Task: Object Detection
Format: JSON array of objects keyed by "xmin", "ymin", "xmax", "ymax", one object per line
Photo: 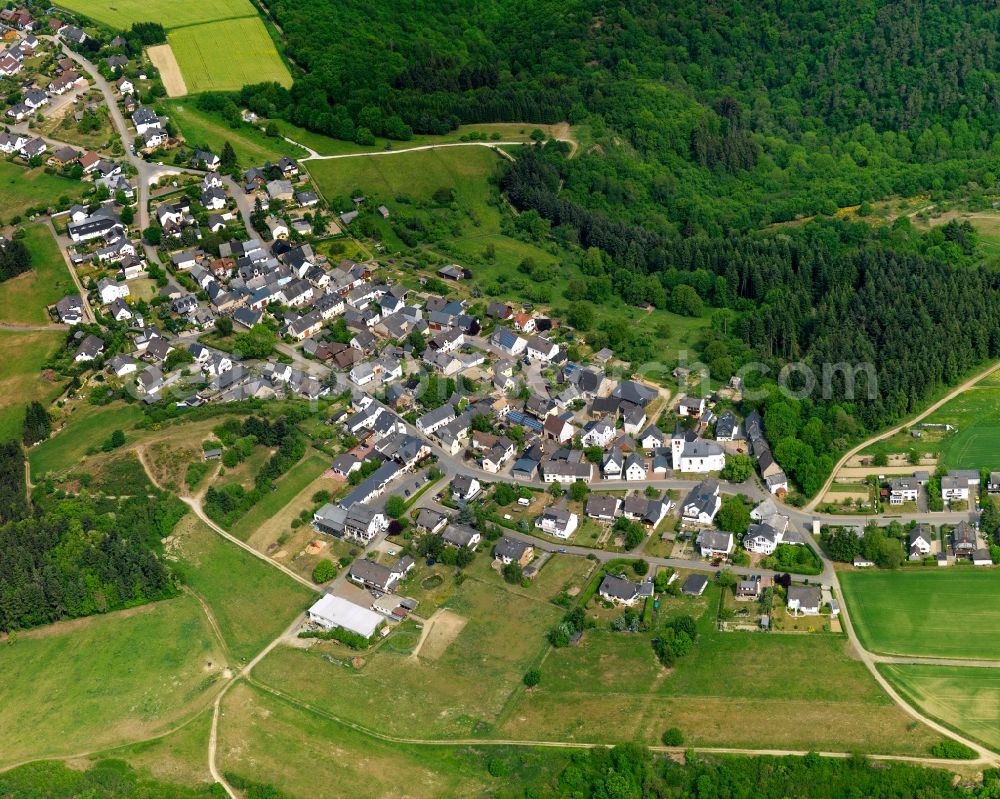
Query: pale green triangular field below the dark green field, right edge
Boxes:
[{"xmin": 879, "ymin": 664, "xmax": 1000, "ymax": 751}]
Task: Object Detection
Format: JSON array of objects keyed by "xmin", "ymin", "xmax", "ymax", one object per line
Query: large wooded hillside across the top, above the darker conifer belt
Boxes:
[{"xmin": 252, "ymin": 0, "xmax": 1000, "ymax": 230}]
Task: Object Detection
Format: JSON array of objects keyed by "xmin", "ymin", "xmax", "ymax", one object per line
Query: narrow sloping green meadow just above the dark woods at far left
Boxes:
[{"xmin": 28, "ymin": 403, "xmax": 142, "ymax": 480}]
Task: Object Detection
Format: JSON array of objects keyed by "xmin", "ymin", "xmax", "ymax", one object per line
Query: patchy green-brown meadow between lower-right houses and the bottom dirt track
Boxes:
[{"xmin": 500, "ymin": 586, "xmax": 938, "ymax": 753}]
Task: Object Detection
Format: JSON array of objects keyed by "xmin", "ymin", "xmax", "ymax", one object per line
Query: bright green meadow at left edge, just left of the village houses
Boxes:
[{"xmin": 0, "ymin": 225, "xmax": 77, "ymax": 325}]
